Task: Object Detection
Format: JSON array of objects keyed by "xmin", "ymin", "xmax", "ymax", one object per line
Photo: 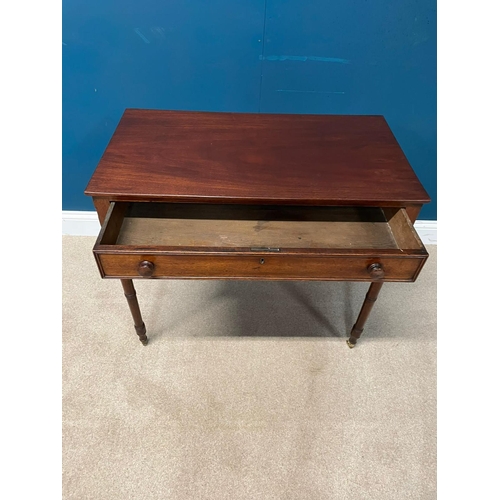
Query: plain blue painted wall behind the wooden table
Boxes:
[{"xmin": 62, "ymin": 0, "xmax": 437, "ymax": 219}]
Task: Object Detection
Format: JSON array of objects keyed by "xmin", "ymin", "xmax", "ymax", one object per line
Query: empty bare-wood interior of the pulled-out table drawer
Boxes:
[{"xmin": 98, "ymin": 202, "xmax": 425, "ymax": 253}]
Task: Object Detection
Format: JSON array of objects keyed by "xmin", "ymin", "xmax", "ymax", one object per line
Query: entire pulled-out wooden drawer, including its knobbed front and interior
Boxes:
[{"xmin": 94, "ymin": 202, "xmax": 428, "ymax": 281}]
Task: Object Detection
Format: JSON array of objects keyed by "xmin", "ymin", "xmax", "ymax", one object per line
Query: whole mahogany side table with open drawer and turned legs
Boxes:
[{"xmin": 85, "ymin": 109, "xmax": 430, "ymax": 347}]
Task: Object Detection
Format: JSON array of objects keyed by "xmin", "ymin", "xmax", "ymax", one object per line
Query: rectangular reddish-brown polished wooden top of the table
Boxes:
[{"xmin": 85, "ymin": 109, "xmax": 430, "ymax": 206}]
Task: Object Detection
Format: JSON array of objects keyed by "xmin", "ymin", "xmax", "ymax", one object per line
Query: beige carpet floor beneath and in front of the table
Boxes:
[{"xmin": 63, "ymin": 236, "xmax": 437, "ymax": 500}]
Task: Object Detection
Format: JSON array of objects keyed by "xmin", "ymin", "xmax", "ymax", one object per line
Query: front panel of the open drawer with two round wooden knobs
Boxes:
[{"xmin": 96, "ymin": 253, "xmax": 426, "ymax": 281}]
